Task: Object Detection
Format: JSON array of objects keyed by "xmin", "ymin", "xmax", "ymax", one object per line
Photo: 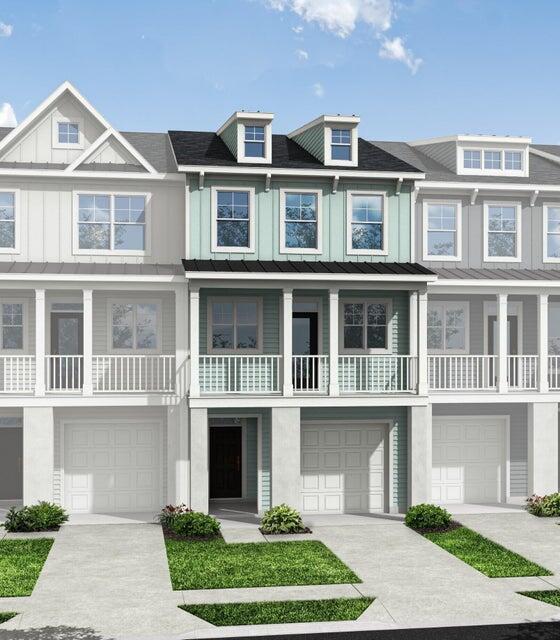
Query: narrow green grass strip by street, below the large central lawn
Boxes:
[{"xmin": 180, "ymin": 598, "xmax": 373, "ymax": 627}]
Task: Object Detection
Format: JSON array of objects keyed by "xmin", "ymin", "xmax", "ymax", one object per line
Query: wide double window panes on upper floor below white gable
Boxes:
[{"xmin": 78, "ymin": 193, "xmax": 147, "ymax": 253}]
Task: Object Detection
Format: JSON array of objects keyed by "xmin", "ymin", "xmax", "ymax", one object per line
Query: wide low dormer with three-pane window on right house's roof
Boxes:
[{"xmin": 410, "ymin": 135, "xmax": 531, "ymax": 178}]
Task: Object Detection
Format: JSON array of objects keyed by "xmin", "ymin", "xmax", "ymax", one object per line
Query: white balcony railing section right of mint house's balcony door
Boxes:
[{"xmin": 338, "ymin": 355, "xmax": 417, "ymax": 393}]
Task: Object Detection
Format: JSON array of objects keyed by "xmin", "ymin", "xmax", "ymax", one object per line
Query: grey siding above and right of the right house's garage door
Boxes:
[{"xmin": 432, "ymin": 403, "xmax": 527, "ymax": 497}]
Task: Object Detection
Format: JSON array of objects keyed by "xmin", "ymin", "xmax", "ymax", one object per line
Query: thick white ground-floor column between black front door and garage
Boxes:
[{"xmin": 271, "ymin": 407, "xmax": 301, "ymax": 511}]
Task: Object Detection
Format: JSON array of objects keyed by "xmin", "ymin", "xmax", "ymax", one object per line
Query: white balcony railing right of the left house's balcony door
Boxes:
[{"xmin": 93, "ymin": 355, "xmax": 175, "ymax": 393}]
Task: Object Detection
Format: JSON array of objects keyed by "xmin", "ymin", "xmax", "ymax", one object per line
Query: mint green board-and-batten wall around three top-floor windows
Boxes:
[{"xmin": 187, "ymin": 177, "xmax": 410, "ymax": 262}]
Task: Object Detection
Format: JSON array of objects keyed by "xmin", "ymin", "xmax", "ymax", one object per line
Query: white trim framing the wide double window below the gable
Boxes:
[{"xmin": 72, "ymin": 190, "xmax": 152, "ymax": 256}]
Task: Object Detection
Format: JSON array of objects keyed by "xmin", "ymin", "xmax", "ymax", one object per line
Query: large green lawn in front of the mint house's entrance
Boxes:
[{"xmin": 165, "ymin": 538, "xmax": 361, "ymax": 590}]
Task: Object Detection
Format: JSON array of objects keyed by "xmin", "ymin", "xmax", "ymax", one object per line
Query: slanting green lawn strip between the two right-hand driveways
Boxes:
[{"xmin": 424, "ymin": 527, "xmax": 552, "ymax": 578}]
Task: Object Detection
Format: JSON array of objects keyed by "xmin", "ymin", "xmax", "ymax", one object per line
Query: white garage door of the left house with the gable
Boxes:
[{"xmin": 63, "ymin": 421, "xmax": 162, "ymax": 513}]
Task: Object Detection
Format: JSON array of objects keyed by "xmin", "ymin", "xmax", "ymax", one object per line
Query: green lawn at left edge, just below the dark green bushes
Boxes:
[{"xmin": 0, "ymin": 538, "xmax": 54, "ymax": 597}]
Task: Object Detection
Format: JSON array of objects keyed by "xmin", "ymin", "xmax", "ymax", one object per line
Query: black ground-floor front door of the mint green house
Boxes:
[{"xmin": 210, "ymin": 426, "xmax": 243, "ymax": 498}]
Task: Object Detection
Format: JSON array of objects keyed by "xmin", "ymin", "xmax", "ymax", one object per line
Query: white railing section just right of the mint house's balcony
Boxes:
[{"xmin": 428, "ymin": 355, "xmax": 498, "ymax": 391}]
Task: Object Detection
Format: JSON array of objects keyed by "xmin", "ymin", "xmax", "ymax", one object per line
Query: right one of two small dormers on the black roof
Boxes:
[{"xmin": 288, "ymin": 115, "xmax": 360, "ymax": 167}]
